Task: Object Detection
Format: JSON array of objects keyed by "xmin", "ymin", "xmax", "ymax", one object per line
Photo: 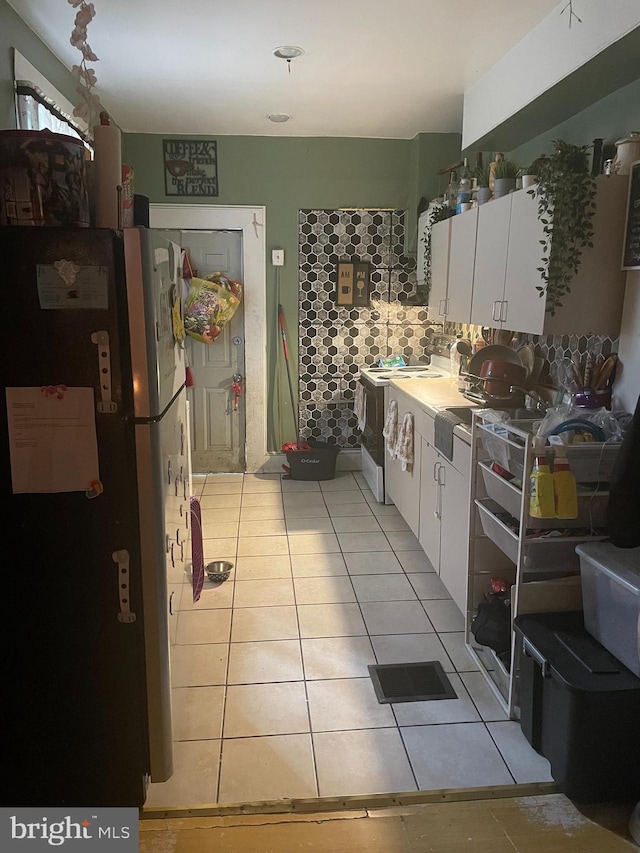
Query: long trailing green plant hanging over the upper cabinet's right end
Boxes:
[{"xmin": 528, "ymin": 140, "xmax": 596, "ymax": 316}]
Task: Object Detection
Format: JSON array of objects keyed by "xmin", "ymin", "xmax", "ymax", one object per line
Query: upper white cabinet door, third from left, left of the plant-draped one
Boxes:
[{"xmin": 471, "ymin": 195, "xmax": 511, "ymax": 328}]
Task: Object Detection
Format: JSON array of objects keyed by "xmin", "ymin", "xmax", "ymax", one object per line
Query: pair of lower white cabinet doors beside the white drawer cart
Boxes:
[{"xmin": 418, "ymin": 437, "xmax": 471, "ymax": 613}]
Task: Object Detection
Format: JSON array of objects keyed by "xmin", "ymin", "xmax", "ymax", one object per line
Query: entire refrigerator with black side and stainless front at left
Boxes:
[{"xmin": 0, "ymin": 227, "xmax": 190, "ymax": 807}]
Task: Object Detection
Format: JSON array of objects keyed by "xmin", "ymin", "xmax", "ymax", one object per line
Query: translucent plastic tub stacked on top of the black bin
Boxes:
[{"xmin": 576, "ymin": 542, "xmax": 640, "ymax": 677}]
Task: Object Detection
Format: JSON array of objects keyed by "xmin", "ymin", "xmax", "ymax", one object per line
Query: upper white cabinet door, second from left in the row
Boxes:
[{"xmin": 447, "ymin": 207, "xmax": 479, "ymax": 323}]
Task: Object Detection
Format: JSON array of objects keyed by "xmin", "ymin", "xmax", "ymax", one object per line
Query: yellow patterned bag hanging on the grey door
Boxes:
[{"xmin": 184, "ymin": 272, "xmax": 242, "ymax": 344}]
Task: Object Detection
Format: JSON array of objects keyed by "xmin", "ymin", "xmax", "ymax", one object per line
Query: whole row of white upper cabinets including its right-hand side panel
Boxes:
[{"xmin": 430, "ymin": 175, "xmax": 628, "ymax": 337}]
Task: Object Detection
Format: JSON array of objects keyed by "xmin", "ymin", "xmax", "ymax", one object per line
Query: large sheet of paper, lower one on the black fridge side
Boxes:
[{"xmin": 6, "ymin": 385, "xmax": 100, "ymax": 494}]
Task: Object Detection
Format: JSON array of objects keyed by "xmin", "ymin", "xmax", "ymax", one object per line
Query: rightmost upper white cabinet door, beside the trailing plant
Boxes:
[{"xmin": 502, "ymin": 190, "xmax": 545, "ymax": 335}]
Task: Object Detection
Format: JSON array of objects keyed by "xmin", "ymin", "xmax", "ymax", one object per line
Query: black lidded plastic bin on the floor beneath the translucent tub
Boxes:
[{"xmin": 514, "ymin": 611, "xmax": 640, "ymax": 803}]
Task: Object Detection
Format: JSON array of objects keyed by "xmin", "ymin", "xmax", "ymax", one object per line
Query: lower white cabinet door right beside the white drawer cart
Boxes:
[{"xmin": 440, "ymin": 458, "xmax": 470, "ymax": 613}]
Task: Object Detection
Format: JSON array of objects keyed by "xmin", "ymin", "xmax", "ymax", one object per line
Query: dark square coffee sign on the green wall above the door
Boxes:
[{"xmin": 162, "ymin": 139, "xmax": 218, "ymax": 197}]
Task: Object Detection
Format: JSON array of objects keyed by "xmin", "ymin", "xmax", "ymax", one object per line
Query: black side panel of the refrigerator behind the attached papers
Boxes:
[{"xmin": 0, "ymin": 228, "xmax": 148, "ymax": 806}]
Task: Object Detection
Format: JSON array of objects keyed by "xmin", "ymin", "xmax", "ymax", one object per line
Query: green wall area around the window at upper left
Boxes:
[{"xmin": 0, "ymin": 0, "xmax": 79, "ymax": 130}]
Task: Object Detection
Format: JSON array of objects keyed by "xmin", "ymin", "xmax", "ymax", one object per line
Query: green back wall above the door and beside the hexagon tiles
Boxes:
[{"xmin": 123, "ymin": 133, "xmax": 460, "ymax": 450}]
